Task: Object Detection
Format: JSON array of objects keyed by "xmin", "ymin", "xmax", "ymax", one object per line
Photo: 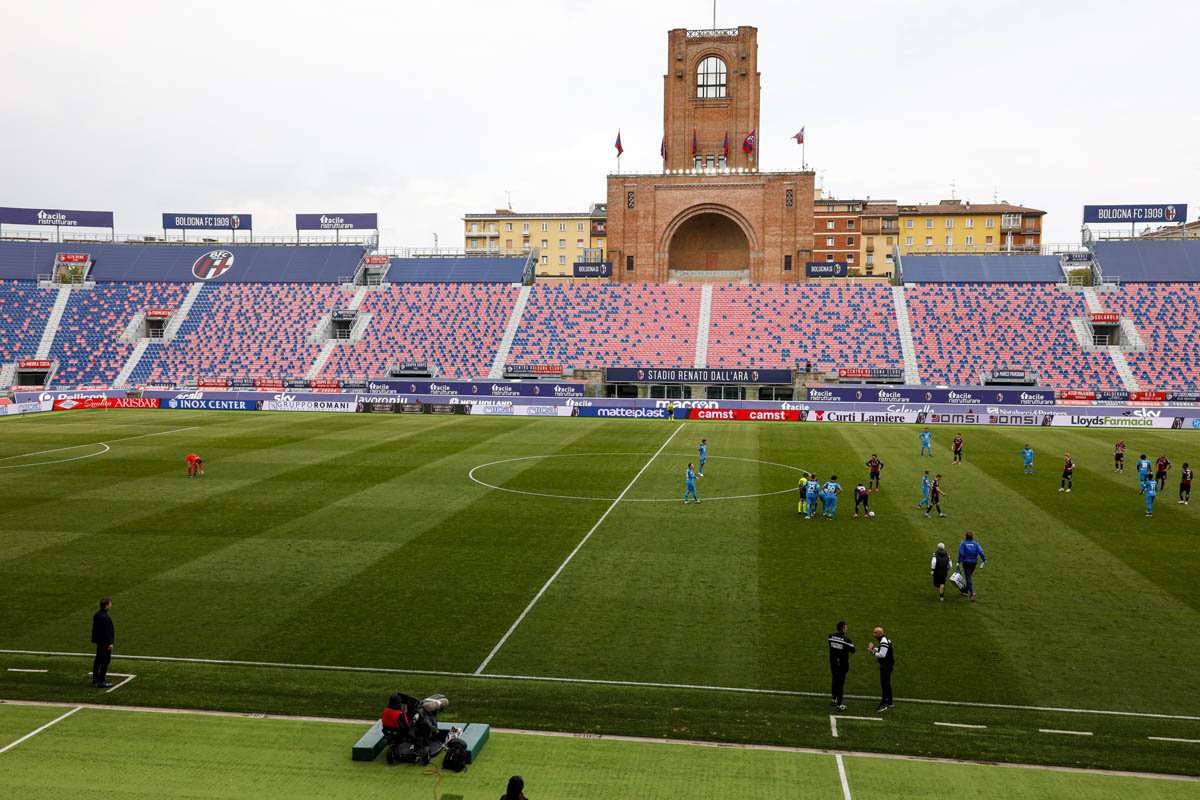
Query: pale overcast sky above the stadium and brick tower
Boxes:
[{"xmin": 0, "ymin": 0, "xmax": 1200, "ymax": 247}]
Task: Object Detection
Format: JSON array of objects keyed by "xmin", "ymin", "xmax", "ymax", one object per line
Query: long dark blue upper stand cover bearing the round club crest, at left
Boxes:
[{"xmin": 0, "ymin": 241, "xmax": 362, "ymax": 283}]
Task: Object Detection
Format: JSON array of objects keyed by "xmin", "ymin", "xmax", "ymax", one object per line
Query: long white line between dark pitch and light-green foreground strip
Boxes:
[{"xmin": 0, "ymin": 698, "xmax": 1200, "ymax": 783}]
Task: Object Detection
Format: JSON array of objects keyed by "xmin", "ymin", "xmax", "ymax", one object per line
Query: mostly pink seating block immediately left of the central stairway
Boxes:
[{"xmin": 508, "ymin": 283, "xmax": 700, "ymax": 369}]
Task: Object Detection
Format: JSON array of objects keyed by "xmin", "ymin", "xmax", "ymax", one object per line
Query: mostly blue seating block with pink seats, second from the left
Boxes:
[{"xmin": 50, "ymin": 283, "xmax": 186, "ymax": 387}]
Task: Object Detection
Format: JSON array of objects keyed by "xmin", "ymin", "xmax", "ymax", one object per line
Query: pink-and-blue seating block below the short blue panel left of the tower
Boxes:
[{"xmin": 316, "ymin": 283, "xmax": 520, "ymax": 378}]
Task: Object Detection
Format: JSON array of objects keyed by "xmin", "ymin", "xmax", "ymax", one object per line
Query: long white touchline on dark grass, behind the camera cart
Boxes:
[{"xmin": 0, "ymin": 649, "xmax": 1200, "ymax": 722}]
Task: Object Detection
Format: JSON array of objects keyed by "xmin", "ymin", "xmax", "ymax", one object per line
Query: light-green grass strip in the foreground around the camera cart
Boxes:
[{"xmin": 0, "ymin": 706, "xmax": 1200, "ymax": 800}]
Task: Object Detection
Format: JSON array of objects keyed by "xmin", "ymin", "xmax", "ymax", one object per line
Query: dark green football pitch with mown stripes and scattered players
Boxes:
[{"xmin": 0, "ymin": 411, "xmax": 1200, "ymax": 798}]
